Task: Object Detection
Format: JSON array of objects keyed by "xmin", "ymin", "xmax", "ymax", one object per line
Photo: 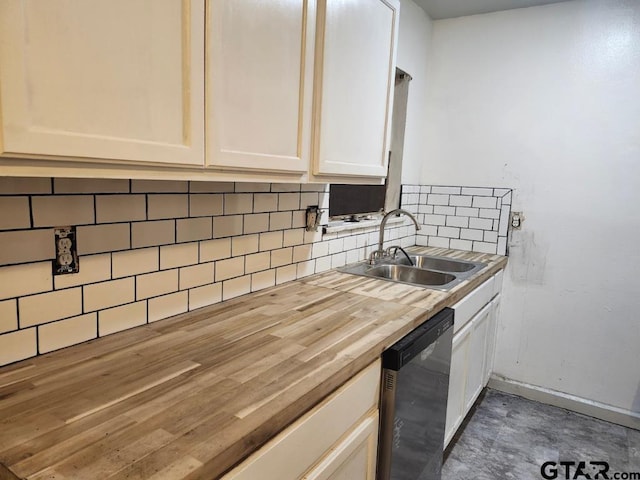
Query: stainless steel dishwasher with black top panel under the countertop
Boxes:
[{"xmin": 377, "ymin": 308, "xmax": 454, "ymax": 480}]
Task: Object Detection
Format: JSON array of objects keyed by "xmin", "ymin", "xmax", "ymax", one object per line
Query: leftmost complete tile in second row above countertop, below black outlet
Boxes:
[{"xmin": 18, "ymin": 287, "xmax": 82, "ymax": 328}]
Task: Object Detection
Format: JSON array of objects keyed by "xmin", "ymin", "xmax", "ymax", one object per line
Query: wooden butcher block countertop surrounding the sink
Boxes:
[{"xmin": 0, "ymin": 248, "xmax": 506, "ymax": 480}]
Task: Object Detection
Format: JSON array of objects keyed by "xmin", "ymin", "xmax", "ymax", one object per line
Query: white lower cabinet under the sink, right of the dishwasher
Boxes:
[{"xmin": 444, "ymin": 273, "xmax": 502, "ymax": 448}]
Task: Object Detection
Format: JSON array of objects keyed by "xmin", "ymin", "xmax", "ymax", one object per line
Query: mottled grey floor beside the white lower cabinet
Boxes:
[{"xmin": 442, "ymin": 390, "xmax": 640, "ymax": 480}]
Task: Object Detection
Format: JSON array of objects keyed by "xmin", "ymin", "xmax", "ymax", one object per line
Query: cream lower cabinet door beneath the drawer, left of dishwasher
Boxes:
[{"xmin": 302, "ymin": 410, "xmax": 378, "ymax": 480}]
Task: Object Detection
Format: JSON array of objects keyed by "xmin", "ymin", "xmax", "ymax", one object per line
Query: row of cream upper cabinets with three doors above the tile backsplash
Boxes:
[{"xmin": 0, "ymin": 0, "xmax": 399, "ymax": 183}]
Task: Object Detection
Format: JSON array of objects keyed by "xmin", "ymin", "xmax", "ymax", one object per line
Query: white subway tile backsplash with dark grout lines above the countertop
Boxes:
[{"xmin": 0, "ymin": 179, "xmax": 478, "ymax": 364}]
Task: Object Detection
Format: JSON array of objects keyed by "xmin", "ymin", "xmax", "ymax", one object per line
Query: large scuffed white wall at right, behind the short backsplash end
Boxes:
[{"xmin": 421, "ymin": 0, "xmax": 640, "ymax": 413}]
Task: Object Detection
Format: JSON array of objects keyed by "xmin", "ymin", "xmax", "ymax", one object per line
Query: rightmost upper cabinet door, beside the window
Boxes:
[{"xmin": 313, "ymin": 0, "xmax": 400, "ymax": 177}]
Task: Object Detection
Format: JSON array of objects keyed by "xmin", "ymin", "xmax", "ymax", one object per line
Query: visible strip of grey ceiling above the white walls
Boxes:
[{"xmin": 415, "ymin": 0, "xmax": 566, "ymax": 20}]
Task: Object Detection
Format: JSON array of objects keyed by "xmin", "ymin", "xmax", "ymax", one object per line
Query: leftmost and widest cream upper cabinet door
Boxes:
[{"xmin": 0, "ymin": 0, "xmax": 204, "ymax": 165}]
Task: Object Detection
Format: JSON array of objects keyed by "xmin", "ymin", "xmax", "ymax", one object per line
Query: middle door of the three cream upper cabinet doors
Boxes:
[{"xmin": 206, "ymin": 0, "xmax": 315, "ymax": 173}]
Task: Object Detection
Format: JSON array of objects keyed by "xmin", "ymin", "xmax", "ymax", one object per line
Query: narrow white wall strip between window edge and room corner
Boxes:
[{"xmin": 396, "ymin": 0, "xmax": 432, "ymax": 184}]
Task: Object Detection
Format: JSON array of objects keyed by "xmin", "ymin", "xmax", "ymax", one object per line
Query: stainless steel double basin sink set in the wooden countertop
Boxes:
[{"xmin": 338, "ymin": 255, "xmax": 485, "ymax": 290}]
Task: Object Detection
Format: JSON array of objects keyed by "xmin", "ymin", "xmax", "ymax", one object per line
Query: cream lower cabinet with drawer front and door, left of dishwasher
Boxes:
[{"xmin": 222, "ymin": 361, "xmax": 381, "ymax": 480}]
